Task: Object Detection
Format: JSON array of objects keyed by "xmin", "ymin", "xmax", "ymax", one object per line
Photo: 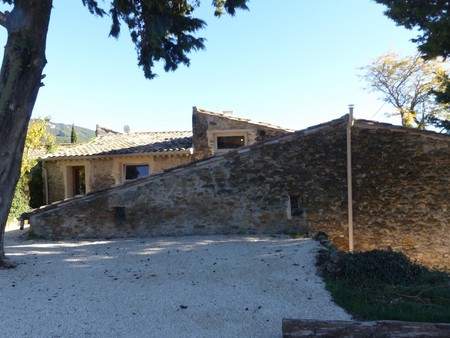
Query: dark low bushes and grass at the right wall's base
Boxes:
[{"xmin": 317, "ymin": 234, "xmax": 450, "ymax": 323}]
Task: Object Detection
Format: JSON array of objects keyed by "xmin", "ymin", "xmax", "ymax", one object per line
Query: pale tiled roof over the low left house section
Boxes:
[{"xmin": 41, "ymin": 131, "xmax": 192, "ymax": 159}]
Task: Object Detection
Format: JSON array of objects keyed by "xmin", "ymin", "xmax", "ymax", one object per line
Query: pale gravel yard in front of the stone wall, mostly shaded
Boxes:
[{"xmin": 0, "ymin": 230, "xmax": 350, "ymax": 338}]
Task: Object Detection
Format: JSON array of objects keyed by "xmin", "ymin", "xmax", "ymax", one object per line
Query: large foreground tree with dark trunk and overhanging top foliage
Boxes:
[{"xmin": 0, "ymin": 0, "xmax": 249, "ymax": 267}]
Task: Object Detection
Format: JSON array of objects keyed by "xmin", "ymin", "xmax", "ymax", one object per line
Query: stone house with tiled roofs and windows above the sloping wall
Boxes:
[{"xmin": 40, "ymin": 107, "xmax": 289, "ymax": 204}]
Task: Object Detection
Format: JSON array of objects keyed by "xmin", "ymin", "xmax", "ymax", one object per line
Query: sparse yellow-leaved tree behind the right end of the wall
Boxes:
[{"xmin": 362, "ymin": 53, "xmax": 448, "ymax": 129}]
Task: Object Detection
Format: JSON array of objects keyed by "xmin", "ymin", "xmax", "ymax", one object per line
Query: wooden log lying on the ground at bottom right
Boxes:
[{"xmin": 282, "ymin": 319, "xmax": 450, "ymax": 338}]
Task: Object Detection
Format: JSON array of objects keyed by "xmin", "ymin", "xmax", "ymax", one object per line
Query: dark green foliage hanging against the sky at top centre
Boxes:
[{"xmin": 82, "ymin": 0, "xmax": 249, "ymax": 79}]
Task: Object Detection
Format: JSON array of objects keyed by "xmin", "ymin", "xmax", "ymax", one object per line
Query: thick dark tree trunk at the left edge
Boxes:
[{"xmin": 0, "ymin": 0, "xmax": 52, "ymax": 267}]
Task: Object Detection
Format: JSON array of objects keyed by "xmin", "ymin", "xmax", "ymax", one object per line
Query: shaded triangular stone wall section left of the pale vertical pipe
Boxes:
[{"xmin": 31, "ymin": 121, "xmax": 346, "ymax": 239}]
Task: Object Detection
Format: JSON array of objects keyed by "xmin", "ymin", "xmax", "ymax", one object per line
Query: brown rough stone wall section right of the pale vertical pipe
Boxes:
[{"xmin": 312, "ymin": 121, "xmax": 450, "ymax": 270}]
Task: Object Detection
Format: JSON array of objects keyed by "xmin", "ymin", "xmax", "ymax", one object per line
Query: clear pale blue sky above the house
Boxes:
[{"xmin": 0, "ymin": 0, "xmax": 416, "ymax": 131}]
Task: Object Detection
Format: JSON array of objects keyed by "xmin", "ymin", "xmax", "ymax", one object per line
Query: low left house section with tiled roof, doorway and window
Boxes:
[{"xmin": 40, "ymin": 131, "xmax": 192, "ymax": 204}]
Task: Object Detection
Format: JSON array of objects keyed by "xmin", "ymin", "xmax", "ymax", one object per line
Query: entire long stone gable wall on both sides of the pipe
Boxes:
[{"xmin": 30, "ymin": 117, "xmax": 450, "ymax": 270}]
